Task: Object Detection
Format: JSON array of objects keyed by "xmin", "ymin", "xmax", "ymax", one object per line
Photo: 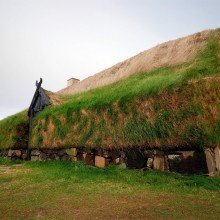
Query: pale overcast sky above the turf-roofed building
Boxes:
[{"xmin": 0, "ymin": 0, "xmax": 220, "ymax": 120}]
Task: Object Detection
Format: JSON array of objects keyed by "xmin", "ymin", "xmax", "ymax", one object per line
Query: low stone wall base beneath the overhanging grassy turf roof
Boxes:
[{"xmin": 0, "ymin": 147, "xmax": 220, "ymax": 175}]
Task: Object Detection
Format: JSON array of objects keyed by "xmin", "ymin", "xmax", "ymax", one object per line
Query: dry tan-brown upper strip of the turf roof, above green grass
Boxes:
[{"xmin": 57, "ymin": 30, "xmax": 213, "ymax": 95}]
